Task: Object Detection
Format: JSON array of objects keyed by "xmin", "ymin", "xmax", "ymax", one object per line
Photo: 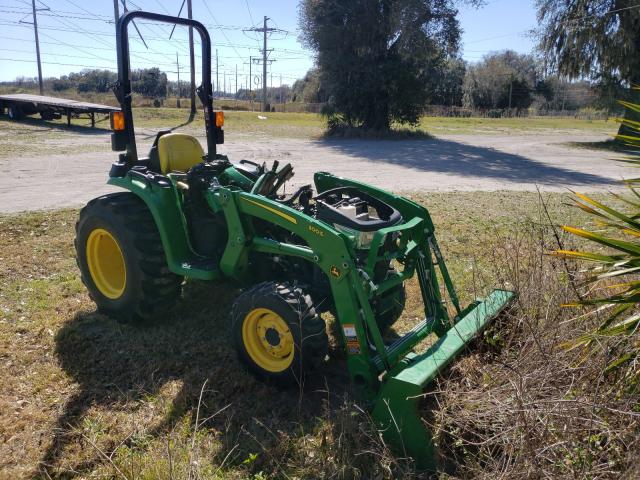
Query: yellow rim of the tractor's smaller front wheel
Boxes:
[{"xmin": 242, "ymin": 308, "xmax": 295, "ymax": 373}]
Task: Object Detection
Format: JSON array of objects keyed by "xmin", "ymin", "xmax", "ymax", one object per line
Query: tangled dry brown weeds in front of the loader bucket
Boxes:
[{"xmin": 427, "ymin": 202, "xmax": 640, "ymax": 479}]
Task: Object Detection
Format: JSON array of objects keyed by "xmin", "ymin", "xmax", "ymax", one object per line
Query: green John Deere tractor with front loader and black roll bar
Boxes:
[{"xmin": 75, "ymin": 11, "xmax": 513, "ymax": 469}]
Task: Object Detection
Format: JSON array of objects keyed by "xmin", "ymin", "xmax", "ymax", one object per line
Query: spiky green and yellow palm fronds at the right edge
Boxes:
[{"xmin": 551, "ymin": 95, "xmax": 640, "ymax": 386}]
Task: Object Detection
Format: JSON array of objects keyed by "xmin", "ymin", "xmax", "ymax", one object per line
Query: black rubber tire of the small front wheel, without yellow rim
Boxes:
[{"xmin": 231, "ymin": 282, "xmax": 329, "ymax": 386}]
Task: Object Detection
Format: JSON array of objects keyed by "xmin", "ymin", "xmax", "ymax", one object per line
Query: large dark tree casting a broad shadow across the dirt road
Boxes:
[{"xmin": 300, "ymin": 0, "xmax": 479, "ymax": 130}]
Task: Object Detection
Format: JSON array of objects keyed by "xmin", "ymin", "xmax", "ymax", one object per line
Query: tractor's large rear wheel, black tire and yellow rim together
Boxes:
[{"xmin": 74, "ymin": 192, "xmax": 183, "ymax": 320}]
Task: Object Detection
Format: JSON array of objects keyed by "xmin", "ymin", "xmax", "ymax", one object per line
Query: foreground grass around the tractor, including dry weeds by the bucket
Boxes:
[{"xmin": 0, "ymin": 192, "xmax": 640, "ymax": 479}]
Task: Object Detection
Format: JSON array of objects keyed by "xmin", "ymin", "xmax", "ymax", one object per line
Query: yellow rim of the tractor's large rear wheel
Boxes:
[{"xmin": 87, "ymin": 228, "xmax": 127, "ymax": 300}]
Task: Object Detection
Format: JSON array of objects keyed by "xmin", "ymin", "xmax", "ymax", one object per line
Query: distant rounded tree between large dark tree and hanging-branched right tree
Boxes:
[{"xmin": 463, "ymin": 50, "xmax": 537, "ymax": 109}]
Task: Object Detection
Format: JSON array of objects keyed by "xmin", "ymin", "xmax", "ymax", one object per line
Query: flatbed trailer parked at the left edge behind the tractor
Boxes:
[{"xmin": 0, "ymin": 93, "xmax": 120, "ymax": 127}]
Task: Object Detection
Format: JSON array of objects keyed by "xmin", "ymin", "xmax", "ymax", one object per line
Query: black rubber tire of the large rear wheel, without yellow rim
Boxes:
[{"xmin": 74, "ymin": 192, "xmax": 183, "ymax": 320}]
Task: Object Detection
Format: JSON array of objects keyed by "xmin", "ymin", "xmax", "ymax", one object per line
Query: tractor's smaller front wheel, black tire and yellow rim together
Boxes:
[{"xmin": 231, "ymin": 282, "xmax": 329, "ymax": 386}]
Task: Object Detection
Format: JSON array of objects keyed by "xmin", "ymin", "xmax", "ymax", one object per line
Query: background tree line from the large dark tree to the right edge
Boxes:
[{"xmin": 294, "ymin": 0, "xmax": 640, "ymax": 130}]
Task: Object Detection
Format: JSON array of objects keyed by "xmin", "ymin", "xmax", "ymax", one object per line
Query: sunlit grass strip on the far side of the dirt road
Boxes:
[{"xmin": 0, "ymin": 108, "xmax": 617, "ymax": 158}]
